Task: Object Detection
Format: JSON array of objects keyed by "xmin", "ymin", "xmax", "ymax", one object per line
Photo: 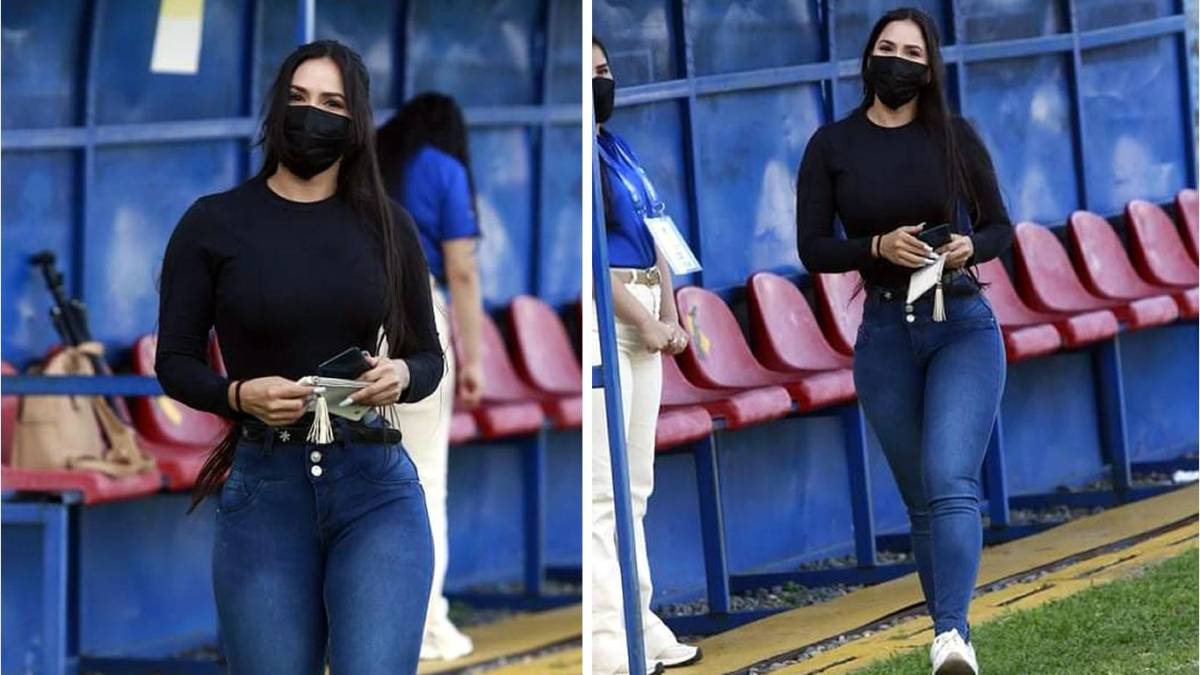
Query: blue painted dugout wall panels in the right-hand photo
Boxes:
[{"xmin": 593, "ymin": 0, "xmax": 1198, "ymax": 602}]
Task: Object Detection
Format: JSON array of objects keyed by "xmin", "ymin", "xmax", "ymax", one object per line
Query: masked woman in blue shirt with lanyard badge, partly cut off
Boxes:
[{"xmin": 592, "ymin": 37, "xmax": 701, "ymax": 674}]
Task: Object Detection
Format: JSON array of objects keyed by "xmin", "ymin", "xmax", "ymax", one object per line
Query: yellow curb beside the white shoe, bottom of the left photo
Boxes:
[{"xmin": 416, "ymin": 604, "xmax": 583, "ymax": 675}]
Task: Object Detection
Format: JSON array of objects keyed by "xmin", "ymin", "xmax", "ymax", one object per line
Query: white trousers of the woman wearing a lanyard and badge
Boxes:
[{"xmin": 592, "ymin": 278, "xmax": 677, "ymax": 675}]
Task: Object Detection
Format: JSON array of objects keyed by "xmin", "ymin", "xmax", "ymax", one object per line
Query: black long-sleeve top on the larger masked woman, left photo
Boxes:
[{"xmin": 155, "ymin": 177, "xmax": 444, "ymax": 419}]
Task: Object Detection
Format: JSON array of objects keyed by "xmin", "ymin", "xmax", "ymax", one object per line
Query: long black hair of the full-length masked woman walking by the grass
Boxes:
[{"xmin": 859, "ymin": 7, "xmax": 979, "ymax": 229}]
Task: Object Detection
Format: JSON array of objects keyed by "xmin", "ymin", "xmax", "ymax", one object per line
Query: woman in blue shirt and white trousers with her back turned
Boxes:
[{"xmin": 378, "ymin": 94, "xmax": 484, "ymax": 661}]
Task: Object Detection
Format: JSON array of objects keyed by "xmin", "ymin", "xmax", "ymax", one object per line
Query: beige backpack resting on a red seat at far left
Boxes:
[{"xmin": 11, "ymin": 342, "xmax": 155, "ymax": 477}]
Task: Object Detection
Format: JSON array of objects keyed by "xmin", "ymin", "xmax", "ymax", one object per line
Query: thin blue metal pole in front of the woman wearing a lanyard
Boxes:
[{"xmin": 592, "ymin": 127, "xmax": 646, "ymax": 675}]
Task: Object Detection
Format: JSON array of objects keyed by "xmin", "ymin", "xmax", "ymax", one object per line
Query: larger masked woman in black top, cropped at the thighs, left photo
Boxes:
[{"xmin": 157, "ymin": 41, "xmax": 443, "ymax": 675}]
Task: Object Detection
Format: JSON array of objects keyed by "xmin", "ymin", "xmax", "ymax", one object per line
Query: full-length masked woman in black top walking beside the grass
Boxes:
[{"xmin": 796, "ymin": 10, "xmax": 1013, "ymax": 675}]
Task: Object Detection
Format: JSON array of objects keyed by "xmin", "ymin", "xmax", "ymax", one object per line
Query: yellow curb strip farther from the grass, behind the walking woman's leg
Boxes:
[{"xmin": 672, "ymin": 484, "xmax": 1200, "ymax": 675}]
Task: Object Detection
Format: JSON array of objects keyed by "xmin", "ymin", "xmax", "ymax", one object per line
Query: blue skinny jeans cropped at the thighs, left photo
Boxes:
[{"xmin": 212, "ymin": 412, "xmax": 433, "ymax": 675}]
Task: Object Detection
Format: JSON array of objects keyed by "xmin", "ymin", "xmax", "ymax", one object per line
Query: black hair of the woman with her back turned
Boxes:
[{"xmin": 376, "ymin": 91, "xmax": 475, "ymax": 208}]
